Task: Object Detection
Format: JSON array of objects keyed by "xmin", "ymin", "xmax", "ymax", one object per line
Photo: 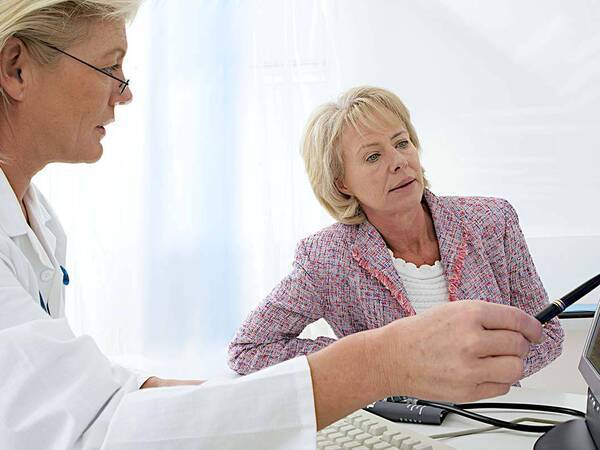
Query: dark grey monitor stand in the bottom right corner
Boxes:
[{"xmin": 533, "ymin": 389, "xmax": 600, "ymax": 450}]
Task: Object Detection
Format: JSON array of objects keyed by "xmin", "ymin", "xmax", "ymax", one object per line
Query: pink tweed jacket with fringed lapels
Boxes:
[{"xmin": 229, "ymin": 191, "xmax": 564, "ymax": 376}]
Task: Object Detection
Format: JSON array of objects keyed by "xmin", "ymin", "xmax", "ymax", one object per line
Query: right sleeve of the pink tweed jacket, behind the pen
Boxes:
[{"xmin": 503, "ymin": 201, "xmax": 564, "ymax": 377}]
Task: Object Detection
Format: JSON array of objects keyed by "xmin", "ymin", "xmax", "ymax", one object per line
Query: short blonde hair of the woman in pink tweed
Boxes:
[{"xmin": 302, "ymin": 86, "xmax": 427, "ymax": 224}]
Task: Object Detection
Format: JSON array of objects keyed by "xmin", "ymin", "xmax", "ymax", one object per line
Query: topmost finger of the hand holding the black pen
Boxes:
[{"xmin": 481, "ymin": 303, "xmax": 542, "ymax": 344}]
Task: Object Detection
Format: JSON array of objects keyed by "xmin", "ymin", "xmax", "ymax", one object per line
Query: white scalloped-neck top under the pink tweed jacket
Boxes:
[{"xmin": 390, "ymin": 250, "xmax": 448, "ymax": 314}]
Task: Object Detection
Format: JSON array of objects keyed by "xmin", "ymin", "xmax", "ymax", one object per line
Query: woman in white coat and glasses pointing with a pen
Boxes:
[{"xmin": 0, "ymin": 0, "xmax": 542, "ymax": 450}]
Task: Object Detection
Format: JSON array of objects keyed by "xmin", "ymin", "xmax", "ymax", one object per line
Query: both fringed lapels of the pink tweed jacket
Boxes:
[{"xmin": 352, "ymin": 190, "xmax": 466, "ymax": 314}]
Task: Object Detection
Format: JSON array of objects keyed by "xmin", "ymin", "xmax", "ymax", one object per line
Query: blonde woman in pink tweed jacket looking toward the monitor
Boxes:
[{"xmin": 229, "ymin": 87, "xmax": 563, "ymax": 377}]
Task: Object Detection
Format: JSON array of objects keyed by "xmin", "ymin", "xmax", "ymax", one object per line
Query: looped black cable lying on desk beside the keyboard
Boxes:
[{"xmin": 413, "ymin": 399, "xmax": 585, "ymax": 433}]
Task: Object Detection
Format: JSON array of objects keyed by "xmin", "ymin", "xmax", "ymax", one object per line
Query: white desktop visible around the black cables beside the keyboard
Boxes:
[{"xmin": 402, "ymin": 387, "xmax": 586, "ymax": 450}]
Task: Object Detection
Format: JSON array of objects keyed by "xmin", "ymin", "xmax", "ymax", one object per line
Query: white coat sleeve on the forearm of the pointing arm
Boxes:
[{"xmin": 102, "ymin": 356, "xmax": 316, "ymax": 450}]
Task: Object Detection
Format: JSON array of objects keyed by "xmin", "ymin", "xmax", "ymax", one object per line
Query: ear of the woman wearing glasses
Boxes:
[{"xmin": 0, "ymin": 37, "xmax": 30, "ymax": 101}]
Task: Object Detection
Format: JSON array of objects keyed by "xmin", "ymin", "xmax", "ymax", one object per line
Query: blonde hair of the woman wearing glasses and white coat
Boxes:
[{"xmin": 0, "ymin": 0, "xmax": 141, "ymax": 101}]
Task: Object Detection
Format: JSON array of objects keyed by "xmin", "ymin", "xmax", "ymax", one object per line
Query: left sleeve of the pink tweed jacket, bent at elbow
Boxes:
[{"xmin": 229, "ymin": 242, "xmax": 334, "ymax": 375}]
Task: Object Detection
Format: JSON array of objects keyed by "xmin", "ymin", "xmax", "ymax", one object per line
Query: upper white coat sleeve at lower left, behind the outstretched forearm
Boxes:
[{"xmin": 0, "ymin": 258, "xmax": 137, "ymax": 450}]
